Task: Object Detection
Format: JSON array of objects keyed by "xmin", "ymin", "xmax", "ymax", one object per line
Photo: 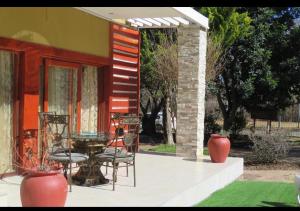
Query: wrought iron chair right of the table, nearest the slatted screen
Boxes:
[{"xmin": 95, "ymin": 113, "xmax": 140, "ymax": 190}]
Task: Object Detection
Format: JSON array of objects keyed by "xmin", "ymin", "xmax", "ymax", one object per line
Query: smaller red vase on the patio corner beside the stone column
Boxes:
[{"xmin": 207, "ymin": 134, "xmax": 230, "ymax": 163}]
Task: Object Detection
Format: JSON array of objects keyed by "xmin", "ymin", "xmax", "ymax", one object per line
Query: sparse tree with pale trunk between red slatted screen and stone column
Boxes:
[{"xmin": 141, "ymin": 29, "xmax": 178, "ymax": 144}]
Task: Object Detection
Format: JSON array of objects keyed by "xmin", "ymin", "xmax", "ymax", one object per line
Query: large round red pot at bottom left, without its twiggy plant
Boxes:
[{"xmin": 20, "ymin": 171, "xmax": 68, "ymax": 207}]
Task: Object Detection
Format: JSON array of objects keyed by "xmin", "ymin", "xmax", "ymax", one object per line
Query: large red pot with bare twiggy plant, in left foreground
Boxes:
[{"xmin": 20, "ymin": 129, "xmax": 68, "ymax": 207}]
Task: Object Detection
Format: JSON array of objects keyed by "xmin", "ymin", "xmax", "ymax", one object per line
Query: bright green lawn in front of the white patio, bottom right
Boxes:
[{"xmin": 196, "ymin": 181, "xmax": 299, "ymax": 207}]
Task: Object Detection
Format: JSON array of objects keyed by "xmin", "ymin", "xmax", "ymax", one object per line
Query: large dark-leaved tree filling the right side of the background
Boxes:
[{"xmin": 214, "ymin": 8, "xmax": 300, "ymax": 133}]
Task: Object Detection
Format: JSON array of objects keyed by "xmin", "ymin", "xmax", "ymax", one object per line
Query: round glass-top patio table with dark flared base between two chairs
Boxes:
[{"xmin": 71, "ymin": 132, "xmax": 109, "ymax": 186}]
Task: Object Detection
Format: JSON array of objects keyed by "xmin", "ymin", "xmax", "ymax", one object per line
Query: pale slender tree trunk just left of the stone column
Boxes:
[{"xmin": 163, "ymin": 97, "xmax": 175, "ymax": 145}]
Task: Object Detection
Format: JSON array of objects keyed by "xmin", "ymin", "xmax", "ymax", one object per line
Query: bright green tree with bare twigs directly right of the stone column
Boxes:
[{"xmin": 200, "ymin": 7, "xmax": 251, "ymax": 134}]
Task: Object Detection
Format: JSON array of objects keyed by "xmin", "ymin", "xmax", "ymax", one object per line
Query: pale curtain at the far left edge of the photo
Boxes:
[{"xmin": 0, "ymin": 51, "xmax": 13, "ymax": 174}]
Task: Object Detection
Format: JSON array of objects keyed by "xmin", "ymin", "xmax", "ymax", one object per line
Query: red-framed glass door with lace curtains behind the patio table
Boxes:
[{"xmin": 44, "ymin": 60, "xmax": 104, "ymax": 134}]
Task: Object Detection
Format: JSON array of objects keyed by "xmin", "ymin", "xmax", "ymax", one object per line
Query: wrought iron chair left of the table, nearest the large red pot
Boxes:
[{"xmin": 39, "ymin": 112, "xmax": 89, "ymax": 192}]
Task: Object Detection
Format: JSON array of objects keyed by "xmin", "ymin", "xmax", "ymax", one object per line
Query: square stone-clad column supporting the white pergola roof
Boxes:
[{"xmin": 176, "ymin": 26, "xmax": 207, "ymax": 160}]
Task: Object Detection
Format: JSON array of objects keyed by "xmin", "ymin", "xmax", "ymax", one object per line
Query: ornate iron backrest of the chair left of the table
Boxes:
[{"xmin": 39, "ymin": 112, "xmax": 71, "ymax": 154}]
